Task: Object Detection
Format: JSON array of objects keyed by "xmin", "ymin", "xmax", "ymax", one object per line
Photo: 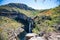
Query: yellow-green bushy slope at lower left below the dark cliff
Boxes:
[{"xmin": 0, "ymin": 16, "xmax": 24, "ymax": 40}]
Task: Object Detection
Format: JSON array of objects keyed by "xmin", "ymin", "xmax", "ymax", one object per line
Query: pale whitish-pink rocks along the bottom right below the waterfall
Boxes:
[{"xmin": 27, "ymin": 32, "xmax": 60, "ymax": 40}]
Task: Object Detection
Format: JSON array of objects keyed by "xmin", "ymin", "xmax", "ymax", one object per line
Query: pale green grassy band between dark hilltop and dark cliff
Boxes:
[{"xmin": 0, "ymin": 6, "xmax": 39, "ymax": 17}]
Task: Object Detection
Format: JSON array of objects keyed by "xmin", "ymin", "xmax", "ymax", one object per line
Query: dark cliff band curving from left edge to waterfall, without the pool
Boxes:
[{"xmin": 0, "ymin": 10, "xmax": 34, "ymax": 33}]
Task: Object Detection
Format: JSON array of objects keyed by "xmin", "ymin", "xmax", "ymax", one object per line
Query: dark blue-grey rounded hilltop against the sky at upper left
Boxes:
[{"xmin": 0, "ymin": 3, "xmax": 35, "ymax": 10}]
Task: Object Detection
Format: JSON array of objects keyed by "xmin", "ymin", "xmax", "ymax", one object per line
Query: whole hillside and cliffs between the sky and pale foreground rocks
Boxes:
[{"xmin": 0, "ymin": 3, "xmax": 60, "ymax": 40}]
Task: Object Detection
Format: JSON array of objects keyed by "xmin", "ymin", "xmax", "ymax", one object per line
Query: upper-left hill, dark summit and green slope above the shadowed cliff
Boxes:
[{"xmin": 0, "ymin": 3, "xmax": 37, "ymax": 17}]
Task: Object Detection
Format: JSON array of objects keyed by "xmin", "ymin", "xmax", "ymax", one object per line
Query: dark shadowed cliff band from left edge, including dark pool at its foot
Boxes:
[{"xmin": 0, "ymin": 12, "xmax": 34, "ymax": 40}]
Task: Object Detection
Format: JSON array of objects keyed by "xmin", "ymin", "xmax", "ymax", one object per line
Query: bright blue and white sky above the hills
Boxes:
[{"xmin": 0, "ymin": 0, "xmax": 60, "ymax": 10}]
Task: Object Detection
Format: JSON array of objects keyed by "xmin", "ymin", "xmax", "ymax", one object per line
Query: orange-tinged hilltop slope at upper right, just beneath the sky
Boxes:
[{"xmin": 38, "ymin": 5, "xmax": 60, "ymax": 15}]
